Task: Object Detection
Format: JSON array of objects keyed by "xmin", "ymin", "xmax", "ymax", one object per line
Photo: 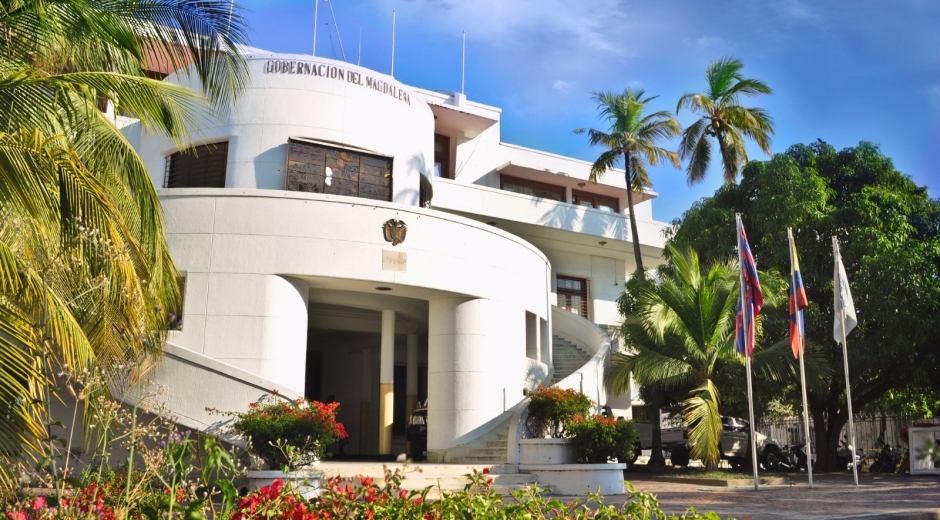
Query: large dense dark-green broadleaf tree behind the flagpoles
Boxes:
[{"xmin": 671, "ymin": 141, "xmax": 940, "ymax": 470}]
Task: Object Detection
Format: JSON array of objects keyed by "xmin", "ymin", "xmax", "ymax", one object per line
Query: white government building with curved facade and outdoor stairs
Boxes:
[{"xmin": 125, "ymin": 53, "xmax": 665, "ymax": 462}]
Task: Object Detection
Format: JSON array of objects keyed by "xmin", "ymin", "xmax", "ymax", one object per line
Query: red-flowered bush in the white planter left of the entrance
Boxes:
[{"xmin": 232, "ymin": 397, "xmax": 347, "ymax": 470}]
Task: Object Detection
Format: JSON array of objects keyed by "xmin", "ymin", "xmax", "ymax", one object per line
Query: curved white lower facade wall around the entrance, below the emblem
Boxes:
[{"xmin": 159, "ymin": 188, "xmax": 551, "ymax": 450}]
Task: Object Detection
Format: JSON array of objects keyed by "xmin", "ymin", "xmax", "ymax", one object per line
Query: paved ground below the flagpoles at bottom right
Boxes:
[{"xmin": 611, "ymin": 472, "xmax": 940, "ymax": 520}]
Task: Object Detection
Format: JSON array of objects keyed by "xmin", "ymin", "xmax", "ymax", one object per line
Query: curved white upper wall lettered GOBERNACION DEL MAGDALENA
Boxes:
[{"xmin": 139, "ymin": 54, "xmax": 434, "ymax": 205}]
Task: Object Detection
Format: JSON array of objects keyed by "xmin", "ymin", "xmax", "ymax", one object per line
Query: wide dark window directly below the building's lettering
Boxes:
[{"xmin": 287, "ymin": 139, "xmax": 392, "ymax": 201}]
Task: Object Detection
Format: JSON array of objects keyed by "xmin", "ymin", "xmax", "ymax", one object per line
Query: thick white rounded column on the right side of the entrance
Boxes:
[{"xmin": 428, "ymin": 298, "xmax": 525, "ymax": 462}]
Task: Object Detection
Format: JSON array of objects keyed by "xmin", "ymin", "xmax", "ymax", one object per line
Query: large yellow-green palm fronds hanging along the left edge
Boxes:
[{"xmin": 0, "ymin": 0, "xmax": 248, "ymax": 480}]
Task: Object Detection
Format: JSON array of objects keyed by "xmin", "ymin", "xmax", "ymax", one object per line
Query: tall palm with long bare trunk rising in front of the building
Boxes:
[{"xmin": 574, "ymin": 87, "xmax": 682, "ymax": 271}]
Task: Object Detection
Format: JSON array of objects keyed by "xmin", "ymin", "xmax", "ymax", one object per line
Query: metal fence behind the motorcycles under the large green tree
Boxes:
[{"xmin": 757, "ymin": 416, "xmax": 940, "ymax": 451}]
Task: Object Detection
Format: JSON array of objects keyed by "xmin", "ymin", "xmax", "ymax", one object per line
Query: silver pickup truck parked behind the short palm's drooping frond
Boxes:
[{"xmin": 634, "ymin": 416, "xmax": 784, "ymax": 471}]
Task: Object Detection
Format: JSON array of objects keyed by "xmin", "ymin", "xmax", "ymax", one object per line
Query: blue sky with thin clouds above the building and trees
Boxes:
[{"xmin": 240, "ymin": 0, "xmax": 940, "ymax": 221}]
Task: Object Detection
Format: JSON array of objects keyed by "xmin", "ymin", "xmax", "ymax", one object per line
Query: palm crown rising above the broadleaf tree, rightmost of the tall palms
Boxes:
[{"xmin": 676, "ymin": 58, "xmax": 774, "ymax": 184}]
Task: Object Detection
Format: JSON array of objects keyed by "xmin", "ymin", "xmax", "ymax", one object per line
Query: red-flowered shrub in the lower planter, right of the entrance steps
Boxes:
[{"xmin": 565, "ymin": 415, "xmax": 639, "ymax": 464}]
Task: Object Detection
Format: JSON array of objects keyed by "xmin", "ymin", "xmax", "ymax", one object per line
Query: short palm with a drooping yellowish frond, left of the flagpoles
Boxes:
[{"xmin": 607, "ymin": 244, "xmax": 793, "ymax": 466}]
